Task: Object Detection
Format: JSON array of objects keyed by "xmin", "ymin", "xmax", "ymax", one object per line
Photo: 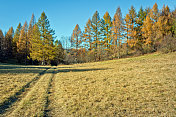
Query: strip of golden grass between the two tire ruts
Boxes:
[{"xmin": 9, "ymin": 70, "xmax": 52, "ymax": 117}]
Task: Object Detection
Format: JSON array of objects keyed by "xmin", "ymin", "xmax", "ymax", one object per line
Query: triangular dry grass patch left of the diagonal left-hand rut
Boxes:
[{"xmin": 0, "ymin": 64, "xmax": 48, "ymax": 104}]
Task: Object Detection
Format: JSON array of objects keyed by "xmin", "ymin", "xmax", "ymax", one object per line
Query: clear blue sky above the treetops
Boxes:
[{"xmin": 0, "ymin": 0, "xmax": 176, "ymax": 39}]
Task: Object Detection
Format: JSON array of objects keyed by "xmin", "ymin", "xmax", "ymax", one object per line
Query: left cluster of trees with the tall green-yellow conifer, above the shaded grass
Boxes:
[{"xmin": 0, "ymin": 12, "xmax": 64, "ymax": 65}]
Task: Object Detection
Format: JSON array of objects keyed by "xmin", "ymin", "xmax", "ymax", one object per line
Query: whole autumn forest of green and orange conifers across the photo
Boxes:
[{"xmin": 0, "ymin": 3, "xmax": 176, "ymax": 65}]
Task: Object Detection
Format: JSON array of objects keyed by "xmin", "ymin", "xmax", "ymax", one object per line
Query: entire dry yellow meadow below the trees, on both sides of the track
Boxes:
[{"xmin": 0, "ymin": 53, "xmax": 176, "ymax": 117}]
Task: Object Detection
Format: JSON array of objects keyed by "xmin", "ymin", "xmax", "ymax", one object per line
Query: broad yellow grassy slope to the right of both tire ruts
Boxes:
[{"xmin": 53, "ymin": 53, "xmax": 176, "ymax": 116}]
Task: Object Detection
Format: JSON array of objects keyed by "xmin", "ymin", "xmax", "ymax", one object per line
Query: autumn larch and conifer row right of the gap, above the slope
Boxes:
[{"xmin": 69, "ymin": 3, "xmax": 176, "ymax": 63}]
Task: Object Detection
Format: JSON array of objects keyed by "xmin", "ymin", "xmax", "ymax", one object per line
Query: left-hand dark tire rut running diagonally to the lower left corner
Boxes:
[{"xmin": 0, "ymin": 68, "xmax": 50, "ymax": 117}]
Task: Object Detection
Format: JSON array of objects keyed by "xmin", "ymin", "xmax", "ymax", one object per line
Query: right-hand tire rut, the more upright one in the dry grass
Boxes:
[{"xmin": 44, "ymin": 68, "xmax": 56, "ymax": 117}]
